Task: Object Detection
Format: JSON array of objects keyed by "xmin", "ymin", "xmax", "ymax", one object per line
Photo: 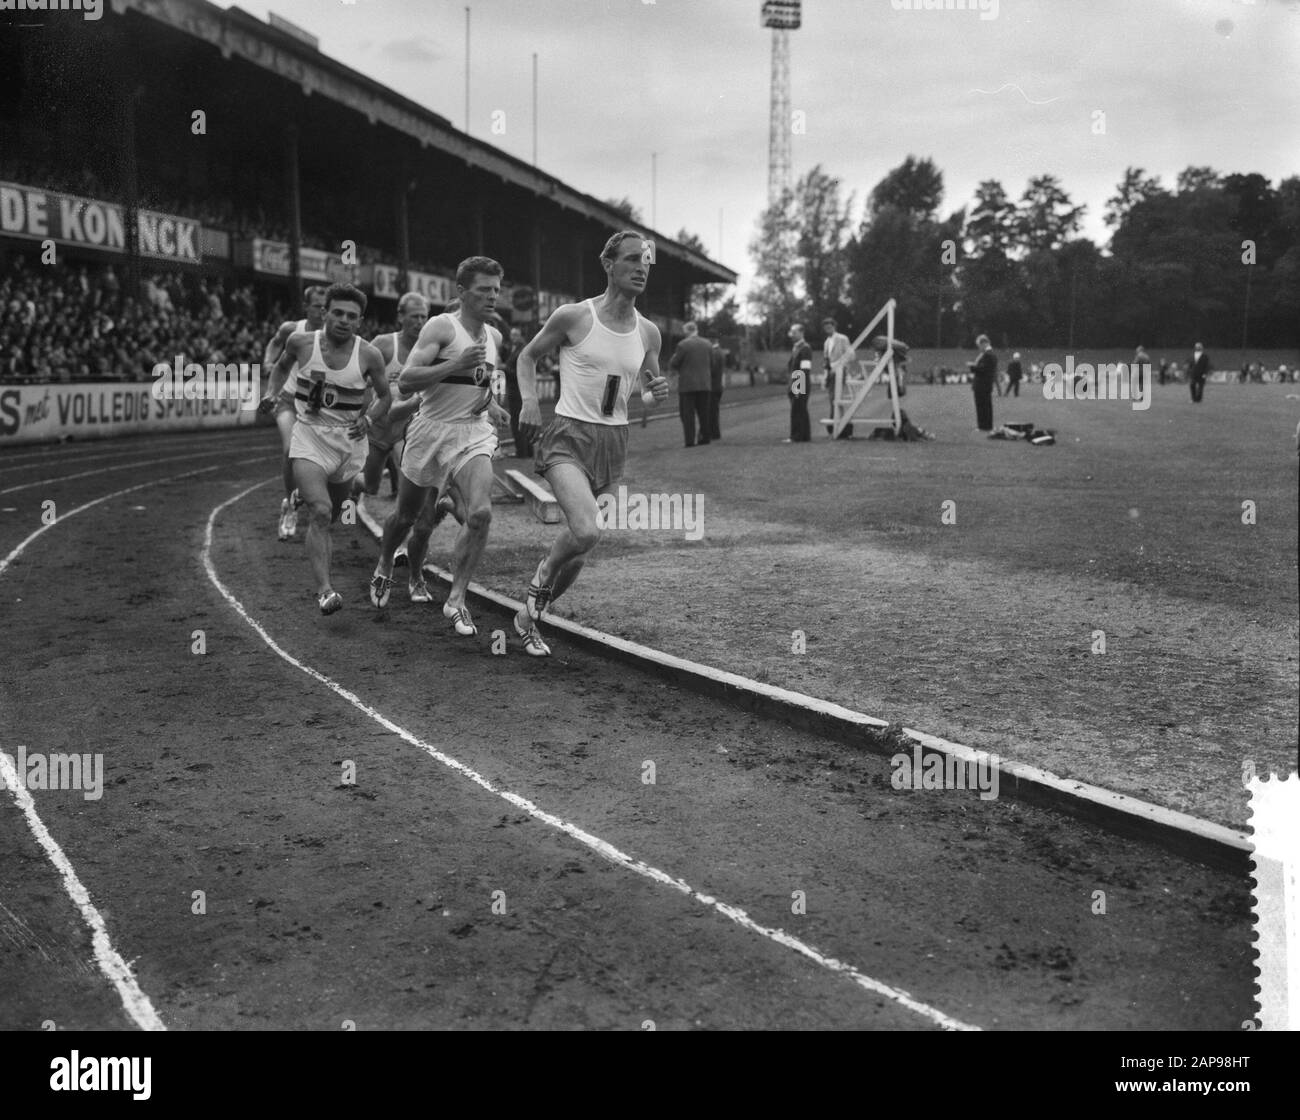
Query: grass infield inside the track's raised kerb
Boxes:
[{"xmin": 378, "ymin": 385, "xmax": 1300, "ymax": 828}]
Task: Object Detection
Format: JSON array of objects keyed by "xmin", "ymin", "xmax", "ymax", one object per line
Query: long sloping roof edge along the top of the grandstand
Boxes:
[{"xmin": 112, "ymin": 0, "xmax": 736, "ymax": 283}]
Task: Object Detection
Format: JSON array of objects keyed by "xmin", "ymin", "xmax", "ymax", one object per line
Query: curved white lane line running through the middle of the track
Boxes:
[{"xmin": 200, "ymin": 479, "xmax": 980, "ymax": 1030}]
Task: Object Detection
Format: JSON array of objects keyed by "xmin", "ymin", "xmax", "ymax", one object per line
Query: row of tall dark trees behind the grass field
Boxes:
[{"xmin": 738, "ymin": 156, "xmax": 1300, "ymax": 350}]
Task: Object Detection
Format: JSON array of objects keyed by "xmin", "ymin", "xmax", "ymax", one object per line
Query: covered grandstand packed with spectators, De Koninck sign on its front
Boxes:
[{"xmin": 0, "ymin": 0, "xmax": 736, "ymax": 400}]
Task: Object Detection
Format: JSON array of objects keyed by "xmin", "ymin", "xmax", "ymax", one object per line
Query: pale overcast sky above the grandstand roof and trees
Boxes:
[{"xmin": 222, "ymin": 0, "xmax": 1300, "ymax": 302}]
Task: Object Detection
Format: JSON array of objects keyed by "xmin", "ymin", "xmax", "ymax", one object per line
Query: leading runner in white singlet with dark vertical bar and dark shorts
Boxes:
[{"xmin": 515, "ymin": 230, "xmax": 668, "ymax": 657}]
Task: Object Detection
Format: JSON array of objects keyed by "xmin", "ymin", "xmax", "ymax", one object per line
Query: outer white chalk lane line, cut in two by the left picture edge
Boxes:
[{"xmin": 0, "ymin": 456, "xmax": 277, "ymax": 1030}]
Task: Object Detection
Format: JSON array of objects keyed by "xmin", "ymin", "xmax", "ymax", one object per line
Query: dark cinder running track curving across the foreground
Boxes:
[{"xmin": 0, "ymin": 430, "xmax": 1253, "ymax": 1029}]
